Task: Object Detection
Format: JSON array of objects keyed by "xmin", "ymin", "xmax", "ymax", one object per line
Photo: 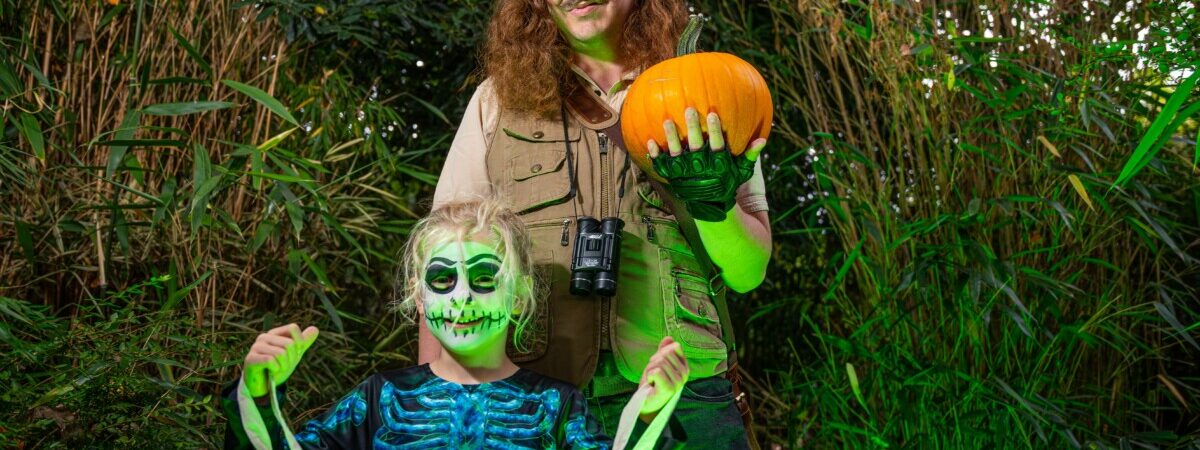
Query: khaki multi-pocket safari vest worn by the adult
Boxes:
[{"xmin": 486, "ymin": 89, "xmax": 728, "ymax": 386}]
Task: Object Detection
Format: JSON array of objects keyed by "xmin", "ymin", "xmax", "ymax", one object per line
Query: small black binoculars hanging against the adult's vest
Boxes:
[{"xmin": 571, "ymin": 216, "xmax": 625, "ymax": 296}]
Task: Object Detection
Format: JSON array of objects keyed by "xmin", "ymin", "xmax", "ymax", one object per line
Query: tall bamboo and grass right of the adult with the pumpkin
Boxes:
[{"xmin": 701, "ymin": 0, "xmax": 1200, "ymax": 449}]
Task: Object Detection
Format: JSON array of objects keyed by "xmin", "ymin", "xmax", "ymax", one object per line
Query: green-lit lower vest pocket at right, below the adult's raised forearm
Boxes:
[{"xmin": 659, "ymin": 248, "xmax": 727, "ymax": 359}]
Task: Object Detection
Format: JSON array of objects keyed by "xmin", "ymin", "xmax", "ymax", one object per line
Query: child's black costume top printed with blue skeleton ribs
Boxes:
[{"xmin": 226, "ymin": 365, "xmax": 678, "ymax": 449}]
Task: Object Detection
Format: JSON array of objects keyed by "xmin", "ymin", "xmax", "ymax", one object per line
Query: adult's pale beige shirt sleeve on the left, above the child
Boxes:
[{"xmin": 433, "ymin": 79, "xmax": 499, "ymax": 209}]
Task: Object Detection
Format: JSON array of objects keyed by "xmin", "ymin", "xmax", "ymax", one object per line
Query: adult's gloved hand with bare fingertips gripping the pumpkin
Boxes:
[{"xmin": 646, "ymin": 108, "xmax": 767, "ymax": 222}]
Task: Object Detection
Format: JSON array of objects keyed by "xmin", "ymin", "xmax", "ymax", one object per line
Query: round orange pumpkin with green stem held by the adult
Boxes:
[{"xmin": 620, "ymin": 18, "xmax": 772, "ymax": 181}]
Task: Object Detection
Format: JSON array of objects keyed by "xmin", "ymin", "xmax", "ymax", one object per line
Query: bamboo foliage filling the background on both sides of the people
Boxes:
[{"xmin": 0, "ymin": 0, "xmax": 1200, "ymax": 449}]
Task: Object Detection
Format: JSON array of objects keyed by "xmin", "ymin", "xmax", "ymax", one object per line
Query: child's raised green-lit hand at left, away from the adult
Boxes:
[{"xmin": 241, "ymin": 324, "xmax": 319, "ymax": 398}]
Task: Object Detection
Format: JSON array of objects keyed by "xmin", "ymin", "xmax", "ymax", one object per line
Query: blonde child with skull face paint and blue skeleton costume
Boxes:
[{"xmin": 226, "ymin": 200, "xmax": 689, "ymax": 449}]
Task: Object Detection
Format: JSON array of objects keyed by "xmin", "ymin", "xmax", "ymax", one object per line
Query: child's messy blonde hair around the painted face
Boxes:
[{"xmin": 395, "ymin": 198, "xmax": 539, "ymax": 352}]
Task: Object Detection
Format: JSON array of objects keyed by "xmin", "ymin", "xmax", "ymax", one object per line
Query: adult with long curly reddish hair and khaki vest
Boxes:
[{"xmin": 432, "ymin": 0, "xmax": 772, "ymax": 449}]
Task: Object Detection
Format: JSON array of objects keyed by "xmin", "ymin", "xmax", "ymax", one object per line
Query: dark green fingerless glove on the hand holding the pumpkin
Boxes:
[{"xmin": 652, "ymin": 144, "xmax": 754, "ymax": 222}]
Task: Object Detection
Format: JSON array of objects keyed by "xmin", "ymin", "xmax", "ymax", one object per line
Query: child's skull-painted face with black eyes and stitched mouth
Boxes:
[{"xmin": 421, "ymin": 241, "xmax": 512, "ymax": 355}]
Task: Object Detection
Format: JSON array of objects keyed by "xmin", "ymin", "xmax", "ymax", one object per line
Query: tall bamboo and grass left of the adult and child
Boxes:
[{"xmin": 0, "ymin": 0, "xmax": 479, "ymax": 448}]
